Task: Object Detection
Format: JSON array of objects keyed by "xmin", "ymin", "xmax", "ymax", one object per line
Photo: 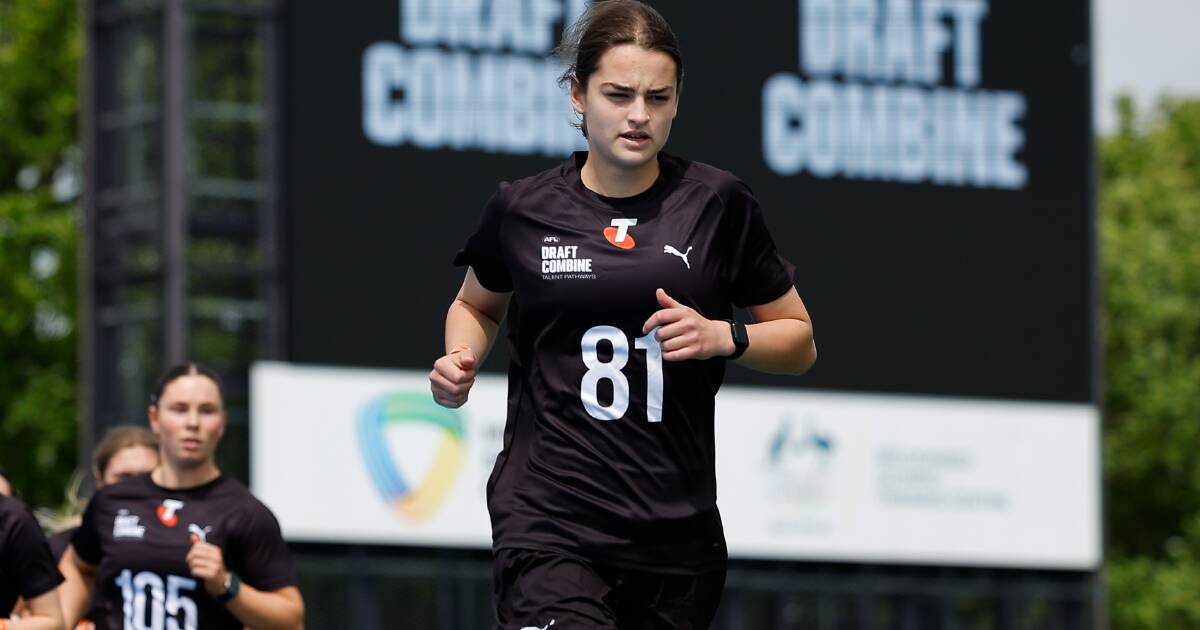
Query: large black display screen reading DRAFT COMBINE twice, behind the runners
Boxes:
[{"xmin": 286, "ymin": 0, "xmax": 1094, "ymax": 403}]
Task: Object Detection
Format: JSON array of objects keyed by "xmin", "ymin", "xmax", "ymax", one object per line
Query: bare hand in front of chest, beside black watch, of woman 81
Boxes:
[{"xmin": 642, "ymin": 289, "xmax": 734, "ymax": 361}]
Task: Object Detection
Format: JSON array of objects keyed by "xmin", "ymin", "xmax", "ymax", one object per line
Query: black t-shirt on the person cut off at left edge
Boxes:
[{"xmin": 0, "ymin": 494, "xmax": 62, "ymax": 612}]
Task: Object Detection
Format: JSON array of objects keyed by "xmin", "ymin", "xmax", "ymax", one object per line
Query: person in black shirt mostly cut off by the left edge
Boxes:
[{"xmin": 0, "ymin": 494, "xmax": 62, "ymax": 630}]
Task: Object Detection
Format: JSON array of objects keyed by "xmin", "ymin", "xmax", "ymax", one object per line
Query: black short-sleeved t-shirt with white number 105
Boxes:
[{"xmin": 71, "ymin": 474, "xmax": 296, "ymax": 630}]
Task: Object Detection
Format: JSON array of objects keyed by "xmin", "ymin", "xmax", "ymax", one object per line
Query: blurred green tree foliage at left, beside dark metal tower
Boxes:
[{"xmin": 0, "ymin": 0, "xmax": 80, "ymax": 505}]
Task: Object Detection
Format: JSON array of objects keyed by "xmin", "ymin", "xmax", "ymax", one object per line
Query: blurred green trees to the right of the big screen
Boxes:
[{"xmin": 1100, "ymin": 100, "xmax": 1200, "ymax": 630}]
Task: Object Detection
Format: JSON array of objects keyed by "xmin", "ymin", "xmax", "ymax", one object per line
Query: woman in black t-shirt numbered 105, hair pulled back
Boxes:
[{"xmin": 60, "ymin": 364, "xmax": 304, "ymax": 630}]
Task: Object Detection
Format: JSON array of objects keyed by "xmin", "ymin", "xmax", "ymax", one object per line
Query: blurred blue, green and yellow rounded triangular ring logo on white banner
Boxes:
[{"xmin": 358, "ymin": 392, "xmax": 466, "ymax": 522}]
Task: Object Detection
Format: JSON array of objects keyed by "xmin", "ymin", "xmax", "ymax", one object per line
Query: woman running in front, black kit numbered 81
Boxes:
[{"xmin": 430, "ymin": 0, "xmax": 816, "ymax": 630}]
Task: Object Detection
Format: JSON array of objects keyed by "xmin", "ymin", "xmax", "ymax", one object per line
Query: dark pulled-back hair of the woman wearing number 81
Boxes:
[{"xmin": 554, "ymin": 0, "xmax": 683, "ymax": 138}]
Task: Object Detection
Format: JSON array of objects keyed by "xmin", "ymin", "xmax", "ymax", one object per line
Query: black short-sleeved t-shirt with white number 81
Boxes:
[{"xmin": 455, "ymin": 154, "xmax": 794, "ymax": 572}]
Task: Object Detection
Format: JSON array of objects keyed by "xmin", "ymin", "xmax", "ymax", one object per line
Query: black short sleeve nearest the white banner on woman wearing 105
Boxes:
[{"xmin": 229, "ymin": 504, "xmax": 298, "ymax": 590}]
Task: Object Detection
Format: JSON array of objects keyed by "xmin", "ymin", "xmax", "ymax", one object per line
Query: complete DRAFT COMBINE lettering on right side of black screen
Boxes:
[{"xmin": 762, "ymin": 0, "xmax": 1028, "ymax": 188}]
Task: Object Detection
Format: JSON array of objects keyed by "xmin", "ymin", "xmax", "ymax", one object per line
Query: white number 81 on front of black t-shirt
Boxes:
[{"xmin": 580, "ymin": 326, "xmax": 662, "ymax": 422}]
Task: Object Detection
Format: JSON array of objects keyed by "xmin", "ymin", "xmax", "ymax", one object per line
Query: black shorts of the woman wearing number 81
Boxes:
[{"xmin": 492, "ymin": 548, "xmax": 725, "ymax": 630}]
